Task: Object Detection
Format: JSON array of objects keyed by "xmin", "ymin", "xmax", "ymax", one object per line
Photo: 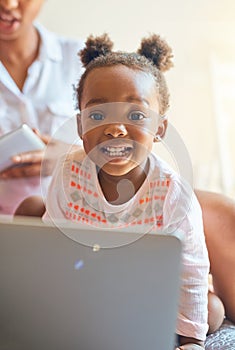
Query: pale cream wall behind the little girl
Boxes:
[{"xmin": 40, "ymin": 0, "xmax": 235, "ymax": 194}]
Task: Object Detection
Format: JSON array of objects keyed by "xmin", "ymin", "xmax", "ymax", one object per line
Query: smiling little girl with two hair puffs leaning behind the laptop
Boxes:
[{"xmin": 46, "ymin": 34, "xmax": 224, "ymax": 350}]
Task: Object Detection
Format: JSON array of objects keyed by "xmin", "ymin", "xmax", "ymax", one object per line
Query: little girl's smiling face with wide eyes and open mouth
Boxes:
[{"xmin": 78, "ymin": 65, "xmax": 164, "ymax": 176}]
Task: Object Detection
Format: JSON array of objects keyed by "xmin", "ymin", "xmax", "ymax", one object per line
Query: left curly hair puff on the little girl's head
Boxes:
[{"xmin": 79, "ymin": 33, "xmax": 113, "ymax": 67}]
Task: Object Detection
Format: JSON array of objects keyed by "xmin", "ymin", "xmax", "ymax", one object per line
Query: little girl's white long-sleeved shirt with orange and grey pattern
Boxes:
[{"xmin": 44, "ymin": 153, "xmax": 209, "ymax": 340}]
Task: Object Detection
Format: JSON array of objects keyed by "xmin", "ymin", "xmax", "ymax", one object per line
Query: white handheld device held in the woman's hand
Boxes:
[{"xmin": 0, "ymin": 124, "xmax": 45, "ymax": 172}]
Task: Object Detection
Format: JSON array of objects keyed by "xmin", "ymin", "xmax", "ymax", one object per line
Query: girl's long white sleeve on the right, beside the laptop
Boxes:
[{"xmin": 164, "ymin": 176, "xmax": 209, "ymax": 340}]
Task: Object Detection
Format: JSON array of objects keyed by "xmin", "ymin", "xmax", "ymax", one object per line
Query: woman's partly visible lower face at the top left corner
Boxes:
[{"xmin": 0, "ymin": 0, "xmax": 44, "ymax": 40}]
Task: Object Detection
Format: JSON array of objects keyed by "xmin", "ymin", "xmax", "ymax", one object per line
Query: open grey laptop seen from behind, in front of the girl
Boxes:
[{"xmin": 0, "ymin": 218, "xmax": 181, "ymax": 350}]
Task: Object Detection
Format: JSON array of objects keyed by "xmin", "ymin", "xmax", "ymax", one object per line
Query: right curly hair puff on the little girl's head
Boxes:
[{"xmin": 137, "ymin": 34, "xmax": 173, "ymax": 72}]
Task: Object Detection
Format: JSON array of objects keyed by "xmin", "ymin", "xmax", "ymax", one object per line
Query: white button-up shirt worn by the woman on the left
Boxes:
[{"xmin": 0, "ymin": 24, "xmax": 83, "ymax": 214}]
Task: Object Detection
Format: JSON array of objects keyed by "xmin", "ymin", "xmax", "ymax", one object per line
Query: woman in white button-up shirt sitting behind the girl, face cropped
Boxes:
[{"xmin": 0, "ymin": 0, "xmax": 83, "ymax": 214}]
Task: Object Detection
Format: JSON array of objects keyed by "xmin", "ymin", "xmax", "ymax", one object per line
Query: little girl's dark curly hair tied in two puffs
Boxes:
[{"xmin": 76, "ymin": 33, "xmax": 173, "ymax": 115}]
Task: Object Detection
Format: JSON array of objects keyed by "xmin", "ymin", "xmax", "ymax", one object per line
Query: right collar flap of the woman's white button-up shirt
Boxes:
[{"xmin": 34, "ymin": 22, "xmax": 62, "ymax": 61}]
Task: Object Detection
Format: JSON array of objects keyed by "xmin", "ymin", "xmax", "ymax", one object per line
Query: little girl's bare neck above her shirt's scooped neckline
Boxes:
[{"xmin": 98, "ymin": 160, "xmax": 149, "ymax": 205}]
